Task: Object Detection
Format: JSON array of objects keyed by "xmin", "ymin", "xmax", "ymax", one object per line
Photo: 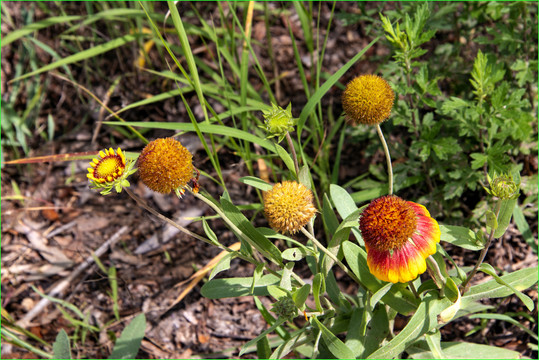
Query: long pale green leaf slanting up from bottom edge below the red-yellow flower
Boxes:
[{"xmin": 368, "ymin": 293, "xmax": 451, "ymax": 359}]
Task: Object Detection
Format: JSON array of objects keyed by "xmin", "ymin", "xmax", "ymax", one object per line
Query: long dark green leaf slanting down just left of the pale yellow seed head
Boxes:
[{"xmin": 221, "ymin": 197, "xmax": 283, "ymax": 264}]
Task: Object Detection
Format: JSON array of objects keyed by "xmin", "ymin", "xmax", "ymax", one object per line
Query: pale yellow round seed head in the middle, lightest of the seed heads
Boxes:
[{"xmin": 264, "ymin": 181, "xmax": 316, "ymax": 234}]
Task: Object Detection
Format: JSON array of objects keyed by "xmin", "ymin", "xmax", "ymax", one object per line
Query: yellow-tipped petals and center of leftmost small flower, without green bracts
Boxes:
[{"xmin": 86, "ymin": 148, "xmax": 126, "ymax": 184}]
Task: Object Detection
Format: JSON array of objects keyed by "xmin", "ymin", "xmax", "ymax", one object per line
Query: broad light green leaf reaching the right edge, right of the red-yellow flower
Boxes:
[{"xmin": 462, "ymin": 266, "xmax": 537, "ymax": 301}]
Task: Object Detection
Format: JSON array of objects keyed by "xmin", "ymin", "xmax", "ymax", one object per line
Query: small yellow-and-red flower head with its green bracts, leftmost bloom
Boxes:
[{"xmin": 86, "ymin": 148, "xmax": 136, "ymax": 195}]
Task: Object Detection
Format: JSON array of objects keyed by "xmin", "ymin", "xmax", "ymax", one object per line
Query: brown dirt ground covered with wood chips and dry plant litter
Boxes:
[{"xmin": 1, "ymin": 2, "xmax": 538, "ymax": 358}]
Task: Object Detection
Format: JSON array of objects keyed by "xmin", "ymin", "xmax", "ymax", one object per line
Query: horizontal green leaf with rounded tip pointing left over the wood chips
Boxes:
[{"xmin": 200, "ymin": 274, "xmax": 280, "ymax": 299}]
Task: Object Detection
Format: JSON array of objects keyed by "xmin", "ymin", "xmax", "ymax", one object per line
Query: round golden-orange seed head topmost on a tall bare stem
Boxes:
[{"xmin": 342, "ymin": 75, "xmax": 395, "ymax": 125}]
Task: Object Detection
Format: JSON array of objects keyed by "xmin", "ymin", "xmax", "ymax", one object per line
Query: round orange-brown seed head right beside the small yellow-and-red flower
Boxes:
[{"xmin": 137, "ymin": 138, "xmax": 198, "ymax": 197}]
